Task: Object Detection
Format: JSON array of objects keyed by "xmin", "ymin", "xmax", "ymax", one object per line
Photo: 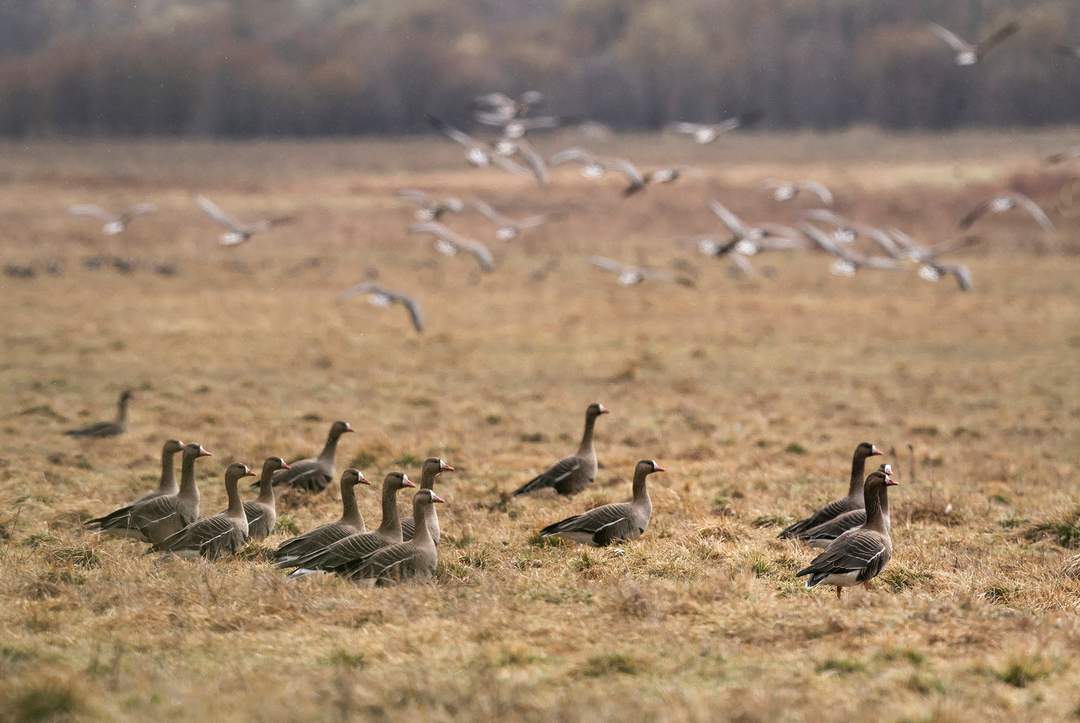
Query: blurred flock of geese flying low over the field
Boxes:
[{"xmin": 46, "ymin": 22, "xmax": 1080, "ymax": 332}]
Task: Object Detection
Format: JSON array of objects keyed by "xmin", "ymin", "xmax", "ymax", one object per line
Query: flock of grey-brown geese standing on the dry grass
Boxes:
[{"xmin": 76, "ymin": 391, "xmax": 896, "ymax": 598}]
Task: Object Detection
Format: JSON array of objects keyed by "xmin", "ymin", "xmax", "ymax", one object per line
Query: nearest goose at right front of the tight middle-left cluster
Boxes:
[{"xmin": 342, "ymin": 490, "xmax": 446, "ymax": 585}]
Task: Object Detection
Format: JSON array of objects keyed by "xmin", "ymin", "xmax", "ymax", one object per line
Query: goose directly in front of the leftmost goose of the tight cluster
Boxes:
[{"xmin": 93, "ymin": 443, "xmax": 211, "ymax": 543}]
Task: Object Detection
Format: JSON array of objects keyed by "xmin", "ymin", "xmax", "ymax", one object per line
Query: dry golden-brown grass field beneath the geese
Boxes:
[{"xmin": 0, "ymin": 131, "xmax": 1080, "ymax": 721}]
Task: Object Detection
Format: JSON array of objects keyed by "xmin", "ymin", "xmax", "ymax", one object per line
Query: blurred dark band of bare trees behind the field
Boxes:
[{"xmin": 0, "ymin": 0, "xmax": 1080, "ymax": 136}]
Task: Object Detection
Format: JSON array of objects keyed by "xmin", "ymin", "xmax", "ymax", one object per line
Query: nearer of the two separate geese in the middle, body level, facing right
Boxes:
[{"xmin": 540, "ymin": 459, "xmax": 664, "ymax": 547}]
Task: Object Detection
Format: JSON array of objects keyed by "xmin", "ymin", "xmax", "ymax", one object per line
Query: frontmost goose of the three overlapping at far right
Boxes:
[{"xmin": 795, "ymin": 462, "xmax": 896, "ymax": 600}]
